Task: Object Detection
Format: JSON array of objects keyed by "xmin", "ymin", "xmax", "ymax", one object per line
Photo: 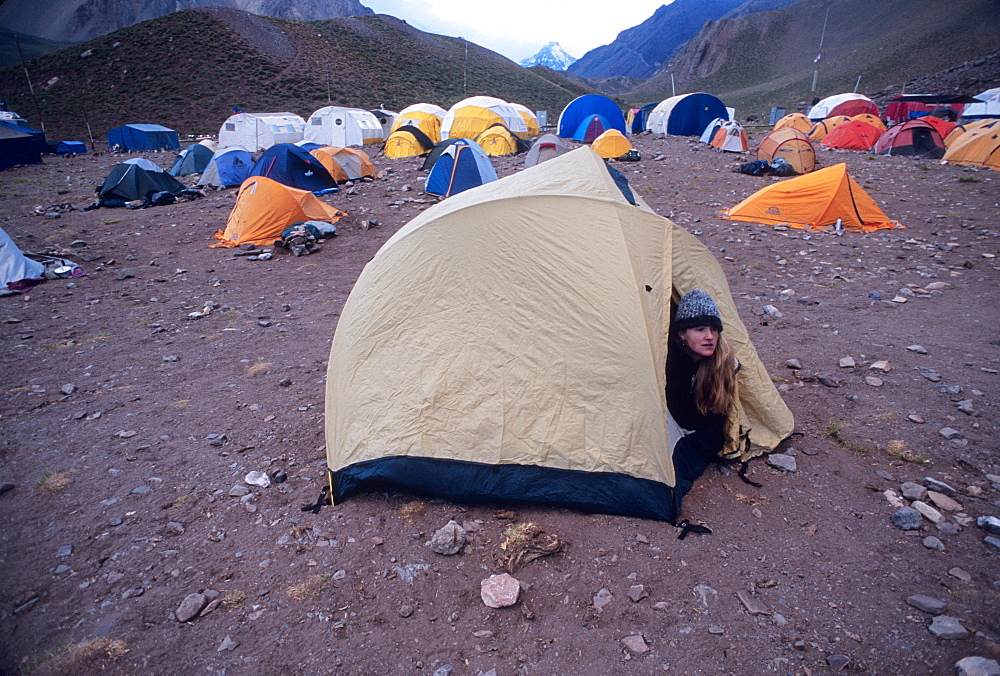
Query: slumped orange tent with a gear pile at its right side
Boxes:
[{"xmin": 212, "ymin": 176, "xmax": 347, "ymax": 247}]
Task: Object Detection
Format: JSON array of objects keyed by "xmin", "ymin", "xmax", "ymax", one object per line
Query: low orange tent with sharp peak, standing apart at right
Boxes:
[{"xmin": 722, "ymin": 164, "xmax": 903, "ymax": 232}]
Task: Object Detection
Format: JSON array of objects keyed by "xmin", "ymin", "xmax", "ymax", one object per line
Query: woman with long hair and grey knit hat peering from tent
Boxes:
[{"xmin": 667, "ymin": 289, "xmax": 739, "ymax": 516}]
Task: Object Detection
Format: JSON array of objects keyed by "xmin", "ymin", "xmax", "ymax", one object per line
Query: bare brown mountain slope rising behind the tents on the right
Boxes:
[{"xmin": 624, "ymin": 0, "xmax": 1000, "ymax": 114}]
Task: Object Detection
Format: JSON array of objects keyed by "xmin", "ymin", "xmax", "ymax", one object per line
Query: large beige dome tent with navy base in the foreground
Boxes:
[{"xmin": 326, "ymin": 148, "xmax": 794, "ymax": 520}]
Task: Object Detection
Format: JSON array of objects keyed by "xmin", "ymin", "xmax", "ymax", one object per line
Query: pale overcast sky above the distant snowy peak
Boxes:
[{"xmin": 361, "ymin": 0, "xmax": 672, "ymax": 61}]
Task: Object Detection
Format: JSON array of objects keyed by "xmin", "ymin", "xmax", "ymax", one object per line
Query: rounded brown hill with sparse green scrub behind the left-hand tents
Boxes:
[{"xmin": 0, "ymin": 8, "xmax": 592, "ymax": 142}]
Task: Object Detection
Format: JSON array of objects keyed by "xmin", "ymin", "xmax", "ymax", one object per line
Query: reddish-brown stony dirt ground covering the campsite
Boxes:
[{"xmin": 0, "ymin": 132, "xmax": 1000, "ymax": 676}]
